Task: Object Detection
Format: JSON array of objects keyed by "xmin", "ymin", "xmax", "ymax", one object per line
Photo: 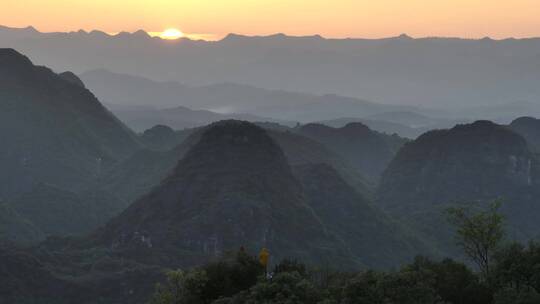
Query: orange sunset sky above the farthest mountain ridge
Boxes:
[{"xmin": 0, "ymin": 0, "xmax": 540, "ymax": 38}]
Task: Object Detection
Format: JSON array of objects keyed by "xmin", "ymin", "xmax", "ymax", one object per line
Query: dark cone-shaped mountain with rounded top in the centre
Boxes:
[{"xmin": 100, "ymin": 121, "xmax": 358, "ymax": 263}]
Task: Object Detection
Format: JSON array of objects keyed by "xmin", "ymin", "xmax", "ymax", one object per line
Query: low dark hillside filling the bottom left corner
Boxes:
[{"xmin": 0, "ymin": 242, "xmax": 163, "ymax": 304}]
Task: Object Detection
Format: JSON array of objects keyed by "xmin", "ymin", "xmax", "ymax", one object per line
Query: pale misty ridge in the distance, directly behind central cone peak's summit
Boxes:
[{"xmin": 80, "ymin": 69, "xmax": 415, "ymax": 126}]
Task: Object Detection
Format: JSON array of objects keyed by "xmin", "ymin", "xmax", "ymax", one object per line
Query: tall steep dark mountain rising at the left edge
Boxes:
[{"xmin": 0, "ymin": 49, "xmax": 141, "ymax": 242}]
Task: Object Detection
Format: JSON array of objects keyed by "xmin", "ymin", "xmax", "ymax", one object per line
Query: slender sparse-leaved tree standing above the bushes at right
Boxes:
[{"xmin": 447, "ymin": 200, "xmax": 504, "ymax": 279}]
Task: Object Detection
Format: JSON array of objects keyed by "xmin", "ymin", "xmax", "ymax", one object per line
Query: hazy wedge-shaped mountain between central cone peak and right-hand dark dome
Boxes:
[{"xmin": 295, "ymin": 123, "xmax": 407, "ymax": 183}]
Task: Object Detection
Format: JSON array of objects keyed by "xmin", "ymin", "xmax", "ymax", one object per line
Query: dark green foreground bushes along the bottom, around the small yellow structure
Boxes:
[{"xmin": 152, "ymin": 252, "xmax": 502, "ymax": 304}]
